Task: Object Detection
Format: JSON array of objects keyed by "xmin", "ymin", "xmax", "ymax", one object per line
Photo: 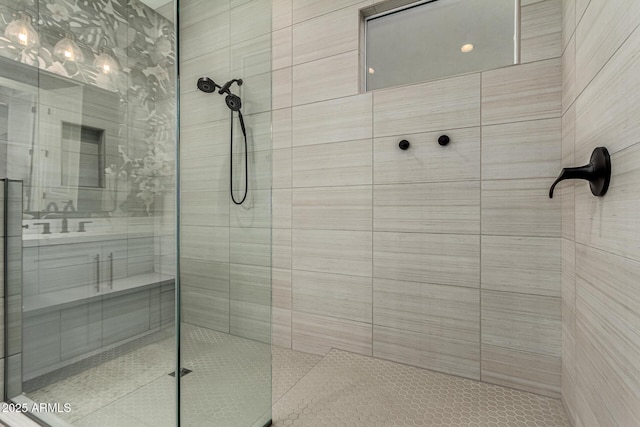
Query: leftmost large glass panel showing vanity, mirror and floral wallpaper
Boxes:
[{"xmin": 0, "ymin": 0, "xmax": 177, "ymax": 426}]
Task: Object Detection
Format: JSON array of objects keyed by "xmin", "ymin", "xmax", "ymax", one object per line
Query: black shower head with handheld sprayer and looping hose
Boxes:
[{"xmin": 198, "ymin": 77, "xmax": 249, "ymax": 205}]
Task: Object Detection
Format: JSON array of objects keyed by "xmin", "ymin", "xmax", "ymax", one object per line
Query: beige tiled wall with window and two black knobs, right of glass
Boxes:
[{"xmin": 272, "ymin": 0, "xmax": 562, "ymax": 396}]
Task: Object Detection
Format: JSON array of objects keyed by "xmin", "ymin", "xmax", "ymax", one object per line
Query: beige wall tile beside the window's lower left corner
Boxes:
[{"xmin": 293, "ymin": 50, "xmax": 360, "ymax": 105}]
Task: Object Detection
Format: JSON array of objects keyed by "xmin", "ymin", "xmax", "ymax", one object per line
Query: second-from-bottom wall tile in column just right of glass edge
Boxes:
[{"xmin": 292, "ymin": 270, "xmax": 372, "ymax": 323}]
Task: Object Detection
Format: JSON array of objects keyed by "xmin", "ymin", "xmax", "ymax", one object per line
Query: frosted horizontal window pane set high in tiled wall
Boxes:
[{"xmin": 364, "ymin": 0, "xmax": 519, "ymax": 90}]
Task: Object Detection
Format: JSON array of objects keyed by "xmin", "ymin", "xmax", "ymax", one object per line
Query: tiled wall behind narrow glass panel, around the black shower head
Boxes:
[{"xmin": 180, "ymin": 0, "xmax": 271, "ymax": 341}]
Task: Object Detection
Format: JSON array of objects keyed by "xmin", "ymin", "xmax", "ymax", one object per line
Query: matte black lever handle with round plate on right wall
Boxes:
[{"xmin": 549, "ymin": 147, "xmax": 611, "ymax": 198}]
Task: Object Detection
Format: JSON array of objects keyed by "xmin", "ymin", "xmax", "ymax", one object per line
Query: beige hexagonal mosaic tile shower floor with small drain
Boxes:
[{"xmin": 23, "ymin": 326, "xmax": 570, "ymax": 427}]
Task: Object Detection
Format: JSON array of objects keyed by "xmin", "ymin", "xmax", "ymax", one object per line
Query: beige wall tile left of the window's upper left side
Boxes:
[{"xmin": 293, "ymin": 3, "xmax": 360, "ymax": 65}]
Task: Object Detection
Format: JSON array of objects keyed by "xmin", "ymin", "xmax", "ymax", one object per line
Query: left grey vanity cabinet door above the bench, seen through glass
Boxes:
[{"xmin": 38, "ymin": 243, "xmax": 103, "ymax": 295}]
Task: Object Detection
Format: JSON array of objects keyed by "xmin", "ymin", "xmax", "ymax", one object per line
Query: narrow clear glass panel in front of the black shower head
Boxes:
[{"xmin": 180, "ymin": 0, "xmax": 271, "ymax": 427}]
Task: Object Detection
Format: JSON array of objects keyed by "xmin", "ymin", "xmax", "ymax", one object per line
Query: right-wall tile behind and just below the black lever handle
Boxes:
[{"xmin": 575, "ymin": 144, "xmax": 640, "ymax": 261}]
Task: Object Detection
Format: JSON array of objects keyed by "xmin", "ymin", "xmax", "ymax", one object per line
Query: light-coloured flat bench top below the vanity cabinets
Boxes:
[{"xmin": 22, "ymin": 273, "xmax": 175, "ymax": 314}]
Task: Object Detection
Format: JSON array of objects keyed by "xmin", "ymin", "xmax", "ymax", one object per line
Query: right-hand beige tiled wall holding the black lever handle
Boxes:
[{"xmin": 561, "ymin": 0, "xmax": 640, "ymax": 427}]
